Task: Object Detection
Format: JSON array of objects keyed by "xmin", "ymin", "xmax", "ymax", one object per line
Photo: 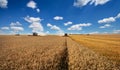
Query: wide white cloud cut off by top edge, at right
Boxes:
[{"xmin": 73, "ymin": 0, "xmax": 110, "ymax": 7}]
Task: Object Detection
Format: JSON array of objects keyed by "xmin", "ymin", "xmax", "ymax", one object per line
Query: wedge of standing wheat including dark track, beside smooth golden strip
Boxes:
[{"xmin": 60, "ymin": 37, "xmax": 120, "ymax": 70}]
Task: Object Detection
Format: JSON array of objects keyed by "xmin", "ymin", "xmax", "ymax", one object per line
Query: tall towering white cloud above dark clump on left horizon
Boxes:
[{"xmin": 24, "ymin": 16, "xmax": 44, "ymax": 32}]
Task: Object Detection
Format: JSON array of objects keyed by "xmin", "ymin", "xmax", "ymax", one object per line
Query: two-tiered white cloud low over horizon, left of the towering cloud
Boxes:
[{"xmin": 10, "ymin": 21, "xmax": 24, "ymax": 33}]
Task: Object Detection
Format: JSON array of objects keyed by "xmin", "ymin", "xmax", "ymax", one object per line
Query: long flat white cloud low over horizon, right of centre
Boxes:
[{"xmin": 68, "ymin": 23, "xmax": 92, "ymax": 30}]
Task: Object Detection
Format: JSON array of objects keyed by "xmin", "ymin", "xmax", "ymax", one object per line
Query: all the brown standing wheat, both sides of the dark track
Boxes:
[{"xmin": 0, "ymin": 36, "xmax": 120, "ymax": 70}]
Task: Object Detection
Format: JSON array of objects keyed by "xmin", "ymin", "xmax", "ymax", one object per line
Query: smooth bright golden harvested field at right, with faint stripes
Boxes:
[{"xmin": 70, "ymin": 34, "xmax": 120, "ymax": 64}]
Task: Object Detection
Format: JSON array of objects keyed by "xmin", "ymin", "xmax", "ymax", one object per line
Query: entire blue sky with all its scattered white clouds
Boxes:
[{"xmin": 0, "ymin": 0, "xmax": 120, "ymax": 35}]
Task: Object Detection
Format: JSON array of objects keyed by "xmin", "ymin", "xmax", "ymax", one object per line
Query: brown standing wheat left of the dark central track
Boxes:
[{"xmin": 0, "ymin": 36, "xmax": 65, "ymax": 70}]
